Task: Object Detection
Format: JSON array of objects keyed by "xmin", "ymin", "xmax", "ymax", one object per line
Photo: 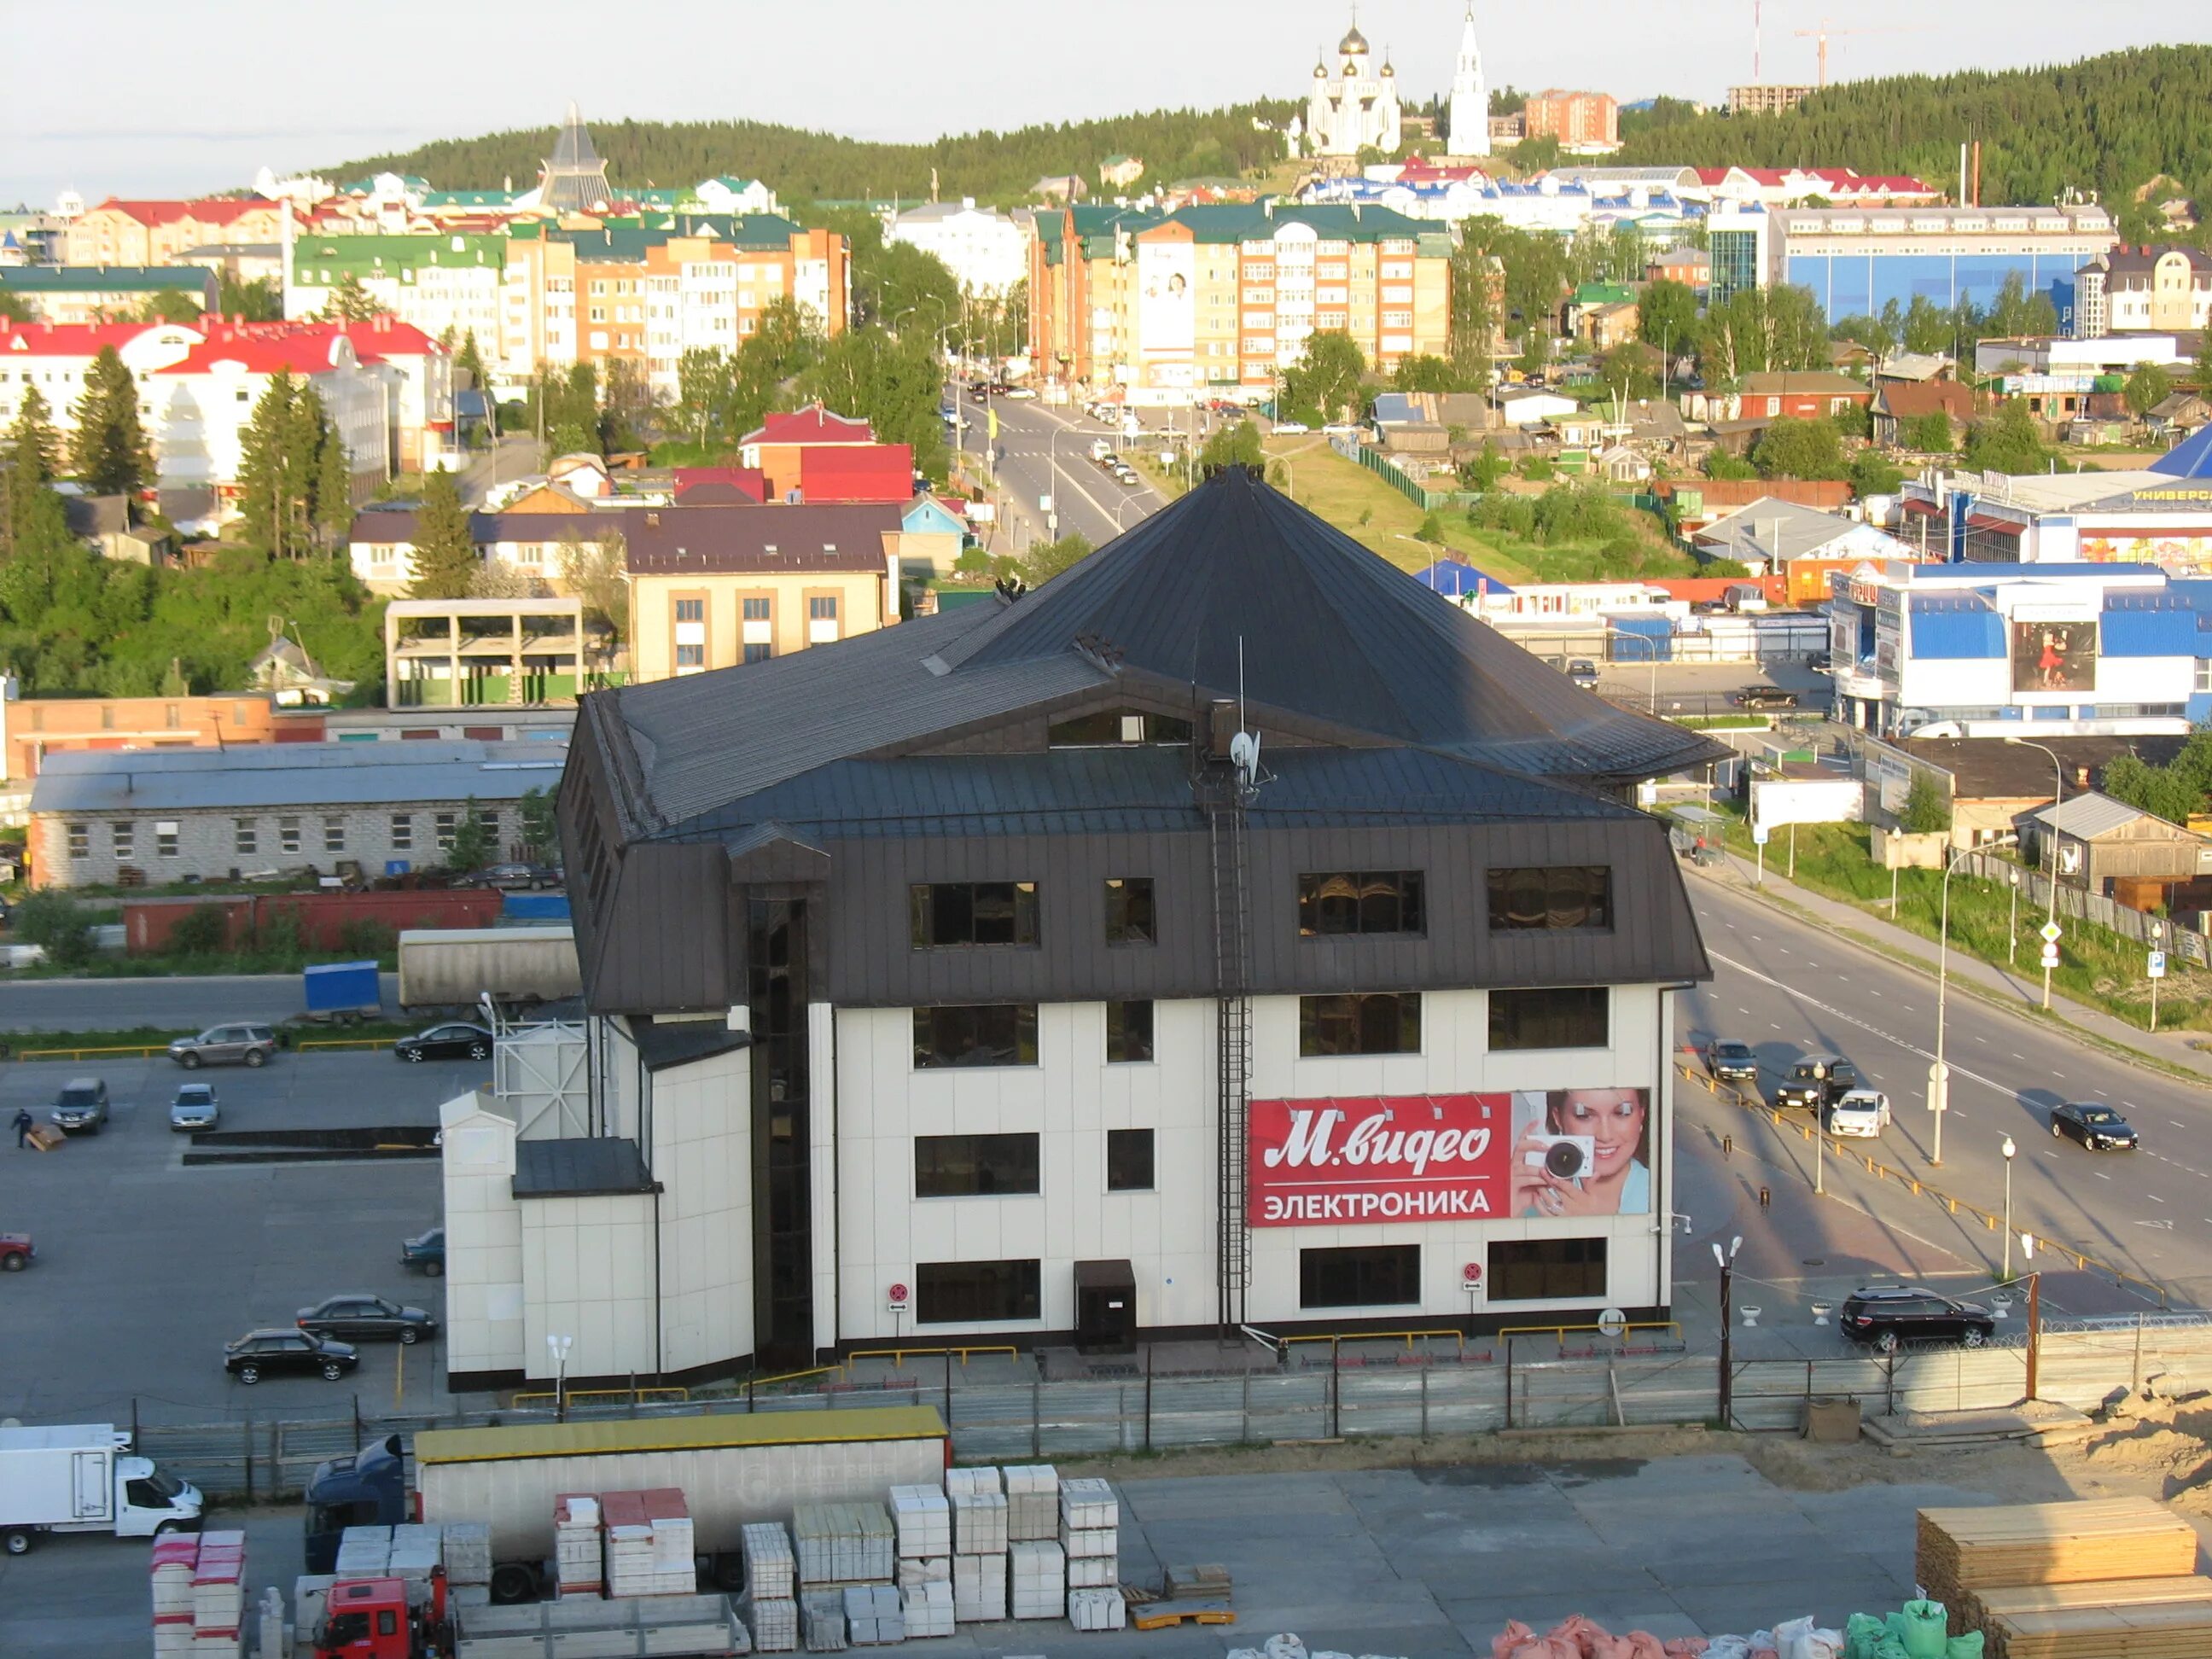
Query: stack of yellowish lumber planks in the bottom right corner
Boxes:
[{"xmin": 1916, "ymin": 1498, "xmax": 2212, "ymax": 1659}]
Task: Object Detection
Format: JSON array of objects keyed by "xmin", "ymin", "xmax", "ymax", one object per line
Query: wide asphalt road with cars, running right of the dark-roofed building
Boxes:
[{"xmin": 1677, "ymin": 876, "xmax": 2212, "ymax": 1305}]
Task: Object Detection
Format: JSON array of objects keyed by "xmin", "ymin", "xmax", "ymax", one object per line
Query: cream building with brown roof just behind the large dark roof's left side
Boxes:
[{"xmin": 628, "ymin": 502, "xmax": 905, "ymax": 681}]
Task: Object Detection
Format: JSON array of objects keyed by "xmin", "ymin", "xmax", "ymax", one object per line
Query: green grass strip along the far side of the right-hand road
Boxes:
[{"xmin": 1727, "ymin": 818, "xmax": 2212, "ymax": 1031}]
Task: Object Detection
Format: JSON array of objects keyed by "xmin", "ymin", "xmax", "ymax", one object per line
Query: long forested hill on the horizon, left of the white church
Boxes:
[{"xmin": 321, "ymin": 104, "xmax": 1292, "ymax": 203}]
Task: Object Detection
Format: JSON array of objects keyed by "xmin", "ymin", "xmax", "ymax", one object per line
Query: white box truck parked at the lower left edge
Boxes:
[{"xmin": 0, "ymin": 1423, "xmax": 206, "ymax": 1555}]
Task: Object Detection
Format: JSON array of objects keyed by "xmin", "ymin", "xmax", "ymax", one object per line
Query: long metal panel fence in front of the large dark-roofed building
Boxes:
[{"xmin": 135, "ymin": 1314, "xmax": 2212, "ymax": 1499}]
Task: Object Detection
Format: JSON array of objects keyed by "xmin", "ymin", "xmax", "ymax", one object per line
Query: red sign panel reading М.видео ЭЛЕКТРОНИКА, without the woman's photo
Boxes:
[{"xmin": 1245, "ymin": 1092, "xmax": 1513, "ymax": 1228}]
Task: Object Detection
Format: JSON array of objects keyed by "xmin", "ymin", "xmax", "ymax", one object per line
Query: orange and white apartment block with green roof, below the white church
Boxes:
[{"xmin": 1031, "ymin": 199, "xmax": 1451, "ymax": 403}]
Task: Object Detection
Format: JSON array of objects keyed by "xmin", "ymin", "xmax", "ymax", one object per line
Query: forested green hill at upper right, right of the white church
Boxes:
[{"xmin": 1617, "ymin": 46, "xmax": 2212, "ymax": 232}]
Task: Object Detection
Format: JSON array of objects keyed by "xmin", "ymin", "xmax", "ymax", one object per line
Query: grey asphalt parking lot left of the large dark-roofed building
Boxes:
[{"xmin": 0, "ymin": 1051, "xmax": 489, "ymax": 1423}]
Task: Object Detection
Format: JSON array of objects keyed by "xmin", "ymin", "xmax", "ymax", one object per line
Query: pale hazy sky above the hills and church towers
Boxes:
[{"xmin": 0, "ymin": 0, "xmax": 2212, "ymax": 206}]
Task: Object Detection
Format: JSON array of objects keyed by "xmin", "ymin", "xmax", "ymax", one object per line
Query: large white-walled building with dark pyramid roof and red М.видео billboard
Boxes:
[{"xmin": 447, "ymin": 469, "xmax": 1712, "ymax": 1376}]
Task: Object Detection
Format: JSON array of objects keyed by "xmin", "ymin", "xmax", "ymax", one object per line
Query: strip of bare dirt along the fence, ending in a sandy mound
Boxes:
[{"xmin": 1057, "ymin": 1391, "xmax": 2212, "ymax": 1522}]
